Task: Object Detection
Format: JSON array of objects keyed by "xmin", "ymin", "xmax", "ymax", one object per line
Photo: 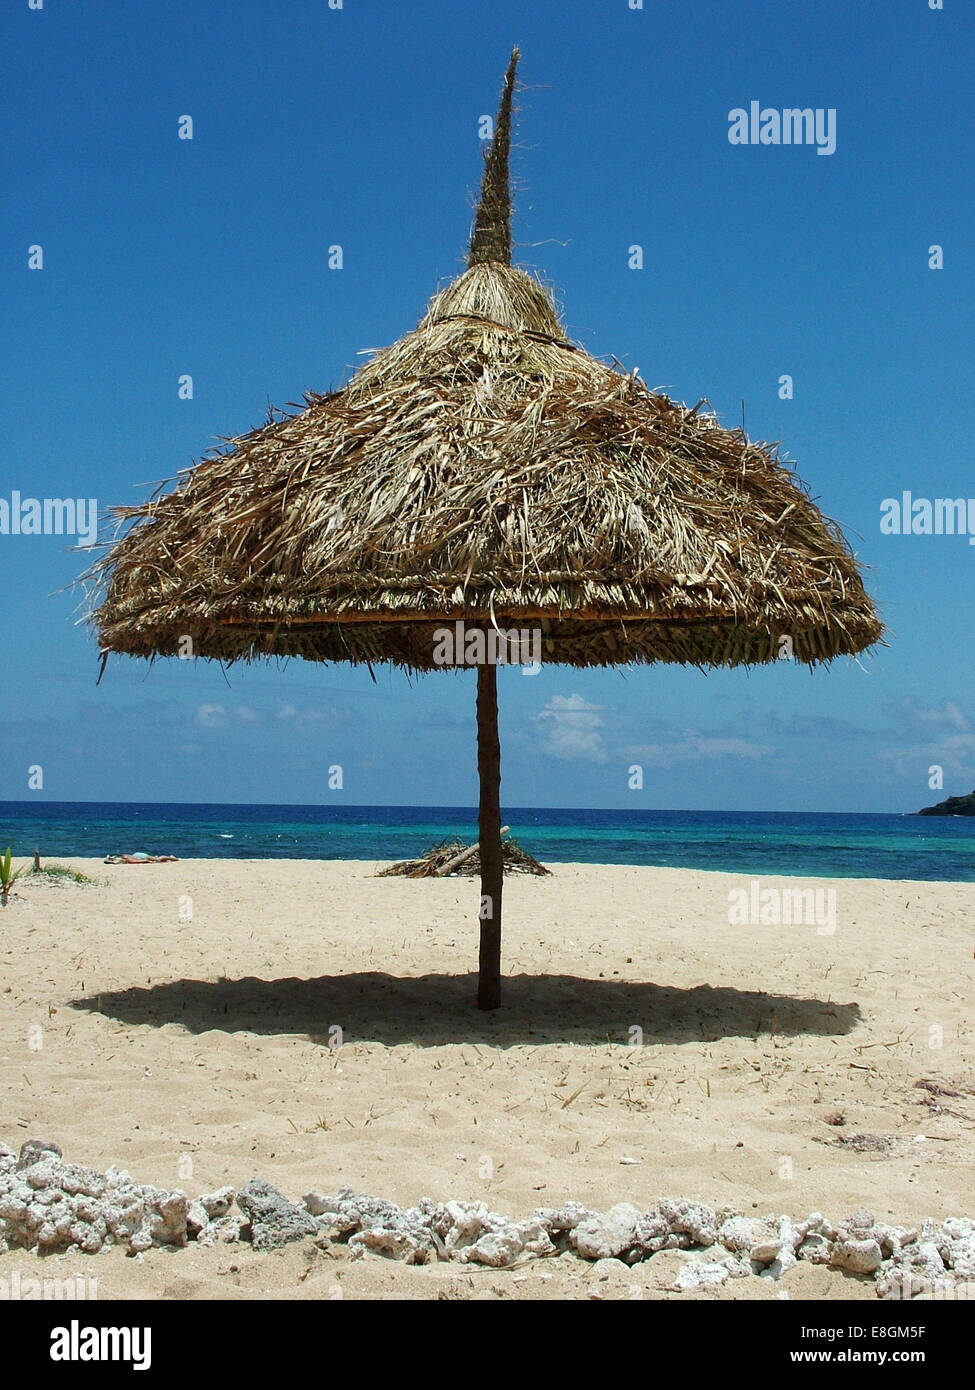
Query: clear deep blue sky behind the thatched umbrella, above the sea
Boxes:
[{"xmin": 0, "ymin": 0, "xmax": 975, "ymax": 810}]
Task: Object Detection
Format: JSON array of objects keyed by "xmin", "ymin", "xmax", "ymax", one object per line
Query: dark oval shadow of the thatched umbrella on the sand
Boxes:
[{"xmin": 70, "ymin": 972, "xmax": 861, "ymax": 1047}]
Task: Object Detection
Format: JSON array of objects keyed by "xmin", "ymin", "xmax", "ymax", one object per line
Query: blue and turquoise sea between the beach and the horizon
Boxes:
[{"xmin": 0, "ymin": 801, "xmax": 975, "ymax": 883}]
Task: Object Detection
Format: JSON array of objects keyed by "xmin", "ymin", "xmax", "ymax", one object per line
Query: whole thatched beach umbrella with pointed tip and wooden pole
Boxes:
[{"xmin": 93, "ymin": 51, "xmax": 882, "ymax": 1009}]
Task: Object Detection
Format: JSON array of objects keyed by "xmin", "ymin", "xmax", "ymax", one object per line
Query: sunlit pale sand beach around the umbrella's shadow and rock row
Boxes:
[{"xmin": 0, "ymin": 859, "xmax": 975, "ymax": 1298}]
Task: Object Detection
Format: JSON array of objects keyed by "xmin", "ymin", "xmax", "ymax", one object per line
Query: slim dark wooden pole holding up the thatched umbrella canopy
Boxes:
[{"xmin": 477, "ymin": 662, "xmax": 503, "ymax": 1009}]
